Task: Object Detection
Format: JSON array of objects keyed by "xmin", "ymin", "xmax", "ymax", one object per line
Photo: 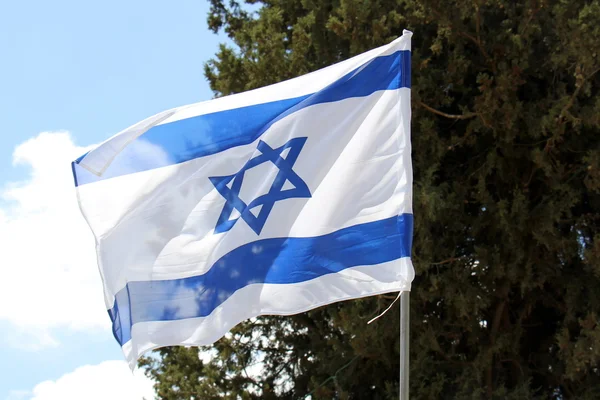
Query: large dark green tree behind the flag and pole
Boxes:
[{"xmin": 141, "ymin": 0, "xmax": 600, "ymax": 400}]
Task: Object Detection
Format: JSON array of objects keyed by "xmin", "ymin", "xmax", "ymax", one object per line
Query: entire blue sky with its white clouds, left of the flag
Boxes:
[{"xmin": 0, "ymin": 0, "xmax": 225, "ymax": 400}]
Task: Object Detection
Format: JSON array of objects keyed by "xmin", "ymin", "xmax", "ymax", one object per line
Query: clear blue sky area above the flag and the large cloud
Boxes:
[{"xmin": 0, "ymin": 0, "xmax": 223, "ymax": 183}]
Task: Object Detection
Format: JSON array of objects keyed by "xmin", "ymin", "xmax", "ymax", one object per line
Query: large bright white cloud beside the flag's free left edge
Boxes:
[{"xmin": 0, "ymin": 132, "xmax": 110, "ymax": 349}]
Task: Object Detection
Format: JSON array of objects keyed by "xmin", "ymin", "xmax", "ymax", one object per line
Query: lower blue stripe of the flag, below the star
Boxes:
[{"xmin": 109, "ymin": 214, "xmax": 413, "ymax": 345}]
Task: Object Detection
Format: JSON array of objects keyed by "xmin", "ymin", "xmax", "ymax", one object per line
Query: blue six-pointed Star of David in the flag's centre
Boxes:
[{"xmin": 209, "ymin": 137, "xmax": 311, "ymax": 235}]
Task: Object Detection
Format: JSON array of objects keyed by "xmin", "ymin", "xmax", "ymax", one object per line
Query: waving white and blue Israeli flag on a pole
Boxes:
[{"xmin": 72, "ymin": 31, "xmax": 414, "ymax": 366}]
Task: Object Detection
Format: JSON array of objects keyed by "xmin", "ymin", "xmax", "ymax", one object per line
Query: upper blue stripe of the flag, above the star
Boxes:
[{"xmin": 74, "ymin": 50, "xmax": 410, "ymax": 185}]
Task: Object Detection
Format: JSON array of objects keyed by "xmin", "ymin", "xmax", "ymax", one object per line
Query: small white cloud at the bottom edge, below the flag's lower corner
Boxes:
[{"xmin": 27, "ymin": 361, "xmax": 154, "ymax": 400}]
